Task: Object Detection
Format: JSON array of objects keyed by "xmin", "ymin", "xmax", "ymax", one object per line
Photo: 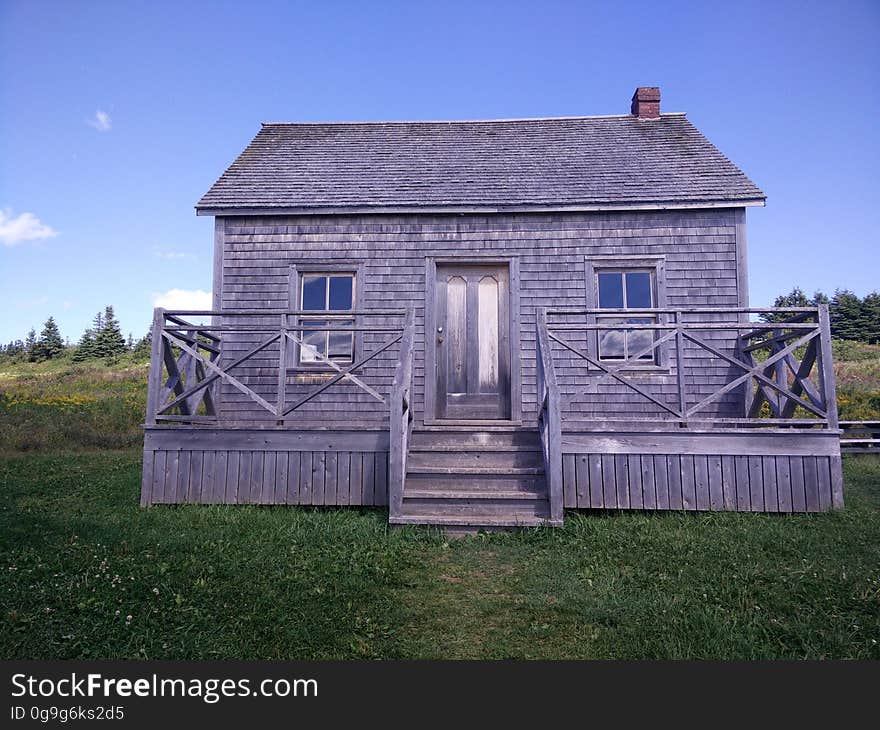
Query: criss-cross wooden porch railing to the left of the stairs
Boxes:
[{"xmin": 146, "ymin": 308, "xmax": 412, "ymax": 426}]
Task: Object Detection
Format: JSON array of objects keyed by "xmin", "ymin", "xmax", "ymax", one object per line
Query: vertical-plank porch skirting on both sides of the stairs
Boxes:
[{"xmin": 141, "ymin": 427, "xmax": 843, "ymax": 512}]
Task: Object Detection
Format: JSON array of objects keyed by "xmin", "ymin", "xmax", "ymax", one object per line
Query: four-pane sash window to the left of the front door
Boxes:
[{"xmin": 298, "ymin": 271, "xmax": 356, "ymax": 366}]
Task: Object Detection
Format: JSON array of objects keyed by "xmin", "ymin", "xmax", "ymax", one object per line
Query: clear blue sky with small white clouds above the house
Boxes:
[{"xmin": 0, "ymin": 0, "xmax": 880, "ymax": 342}]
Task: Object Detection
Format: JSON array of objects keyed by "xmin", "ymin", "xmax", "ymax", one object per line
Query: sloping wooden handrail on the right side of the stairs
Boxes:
[{"xmin": 535, "ymin": 310, "xmax": 563, "ymax": 522}]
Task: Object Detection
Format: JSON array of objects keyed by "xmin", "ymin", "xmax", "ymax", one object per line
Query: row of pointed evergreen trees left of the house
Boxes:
[{"xmin": 0, "ymin": 305, "xmax": 150, "ymax": 362}]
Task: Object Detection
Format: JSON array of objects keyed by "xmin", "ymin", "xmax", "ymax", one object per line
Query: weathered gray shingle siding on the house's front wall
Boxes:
[{"xmin": 218, "ymin": 208, "xmax": 744, "ymax": 425}]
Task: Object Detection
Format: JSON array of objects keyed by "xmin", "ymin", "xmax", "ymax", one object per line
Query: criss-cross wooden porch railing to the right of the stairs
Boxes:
[{"xmin": 537, "ymin": 305, "xmax": 838, "ymax": 430}]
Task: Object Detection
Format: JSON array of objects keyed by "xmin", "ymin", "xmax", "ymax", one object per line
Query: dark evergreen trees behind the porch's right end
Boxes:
[{"xmin": 761, "ymin": 286, "xmax": 880, "ymax": 345}]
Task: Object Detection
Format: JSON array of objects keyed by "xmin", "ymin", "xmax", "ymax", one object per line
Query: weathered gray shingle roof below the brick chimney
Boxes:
[{"xmin": 196, "ymin": 114, "xmax": 765, "ymax": 214}]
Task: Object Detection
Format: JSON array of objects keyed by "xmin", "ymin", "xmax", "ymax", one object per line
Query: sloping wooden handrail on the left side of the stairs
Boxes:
[{"xmin": 388, "ymin": 310, "xmax": 415, "ymax": 517}]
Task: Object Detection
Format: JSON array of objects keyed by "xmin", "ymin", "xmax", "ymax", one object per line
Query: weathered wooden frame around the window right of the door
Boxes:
[{"xmin": 584, "ymin": 255, "xmax": 669, "ymax": 374}]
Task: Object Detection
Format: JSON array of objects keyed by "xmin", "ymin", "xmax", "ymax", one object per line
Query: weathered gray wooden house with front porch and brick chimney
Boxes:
[{"xmin": 142, "ymin": 87, "xmax": 843, "ymax": 529}]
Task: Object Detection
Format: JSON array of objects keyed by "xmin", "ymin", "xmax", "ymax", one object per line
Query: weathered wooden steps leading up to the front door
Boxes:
[{"xmin": 389, "ymin": 425, "xmax": 550, "ymax": 532}]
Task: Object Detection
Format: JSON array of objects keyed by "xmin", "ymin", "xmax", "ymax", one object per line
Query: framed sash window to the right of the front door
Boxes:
[{"xmin": 586, "ymin": 256, "xmax": 665, "ymax": 369}]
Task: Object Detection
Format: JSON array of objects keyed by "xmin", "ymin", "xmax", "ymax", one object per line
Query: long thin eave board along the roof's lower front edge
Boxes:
[{"xmin": 195, "ymin": 197, "xmax": 767, "ymax": 216}]
